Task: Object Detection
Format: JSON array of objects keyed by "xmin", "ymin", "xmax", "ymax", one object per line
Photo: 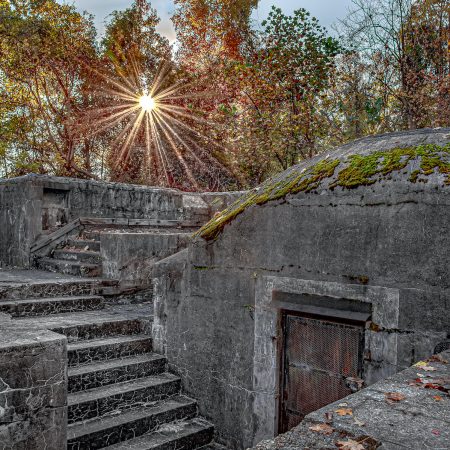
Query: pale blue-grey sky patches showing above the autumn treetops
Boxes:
[{"xmin": 60, "ymin": 0, "xmax": 351, "ymax": 42}]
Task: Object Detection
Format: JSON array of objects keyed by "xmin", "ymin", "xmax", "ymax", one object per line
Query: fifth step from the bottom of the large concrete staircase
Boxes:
[{"xmin": 67, "ymin": 334, "xmax": 152, "ymax": 367}]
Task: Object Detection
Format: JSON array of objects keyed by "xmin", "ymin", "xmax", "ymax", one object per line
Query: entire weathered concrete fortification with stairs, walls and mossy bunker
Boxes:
[{"xmin": 0, "ymin": 129, "xmax": 450, "ymax": 450}]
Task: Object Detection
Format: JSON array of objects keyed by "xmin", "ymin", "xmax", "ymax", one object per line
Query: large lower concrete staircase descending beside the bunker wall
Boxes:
[{"xmin": 0, "ymin": 278, "xmax": 214, "ymax": 450}]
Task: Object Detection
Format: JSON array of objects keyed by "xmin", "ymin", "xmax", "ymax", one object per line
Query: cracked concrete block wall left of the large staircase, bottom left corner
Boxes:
[{"xmin": 0, "ymin": 323, "xmax": 67, "ymax": 450}]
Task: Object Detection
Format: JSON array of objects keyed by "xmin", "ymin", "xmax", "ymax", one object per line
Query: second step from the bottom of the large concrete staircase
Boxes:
[{"xmin": 67, "ymin": 396, "xmax": 197, "ymax": 450}]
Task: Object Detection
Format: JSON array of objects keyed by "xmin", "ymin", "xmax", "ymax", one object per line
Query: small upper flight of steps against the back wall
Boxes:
[{"xmin": 36, "ymin": 230, "xmax": 102, "ymax": 277}]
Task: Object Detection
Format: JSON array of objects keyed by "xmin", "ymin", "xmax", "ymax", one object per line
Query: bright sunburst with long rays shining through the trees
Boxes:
[{"xmin": 74, "ymin": 56, "xmax": 233, "ymax": 190}]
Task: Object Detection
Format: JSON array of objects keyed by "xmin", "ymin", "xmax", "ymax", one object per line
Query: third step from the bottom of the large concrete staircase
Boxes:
[{"xmin": 68, "ymin": 373, "xmax": 181, "ymax": 423}]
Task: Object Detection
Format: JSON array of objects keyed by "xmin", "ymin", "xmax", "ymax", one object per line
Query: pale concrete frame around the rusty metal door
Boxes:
[{"xmin": 252, "ymin": 275, "xmax": 400, "ymax": 445}]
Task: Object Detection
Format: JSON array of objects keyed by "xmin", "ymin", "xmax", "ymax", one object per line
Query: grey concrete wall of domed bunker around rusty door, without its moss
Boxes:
[{"xmin": 154, "ymin": 130, "xmax": 450, "ymax": 449}]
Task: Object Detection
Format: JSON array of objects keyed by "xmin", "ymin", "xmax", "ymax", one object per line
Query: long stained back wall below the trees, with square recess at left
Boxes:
[{"xmin": 0, "ymin": 174, "xmax": 243, "ymax": 268}]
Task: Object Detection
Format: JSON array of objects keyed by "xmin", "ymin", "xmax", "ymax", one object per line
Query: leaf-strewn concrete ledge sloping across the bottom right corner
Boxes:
[{"xmin": 254, "ymin": 351, "xmax": 450, "ymax": 450}]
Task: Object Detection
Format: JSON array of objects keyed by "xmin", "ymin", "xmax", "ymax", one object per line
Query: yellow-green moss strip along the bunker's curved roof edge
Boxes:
[{"xmin": 195, "ymin": 143, "xmax": 450, "ymax": 240}]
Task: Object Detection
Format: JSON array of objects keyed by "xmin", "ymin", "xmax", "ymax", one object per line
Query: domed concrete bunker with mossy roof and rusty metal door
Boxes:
[{"xmin": 153, "ymin": 129, "xmax": 450, "ymax": 449}]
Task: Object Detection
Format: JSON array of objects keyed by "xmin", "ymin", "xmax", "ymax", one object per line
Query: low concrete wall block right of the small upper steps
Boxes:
[{"xmin": 100, "ymin": 229, "xmax": 193, "ymax": 285}]
